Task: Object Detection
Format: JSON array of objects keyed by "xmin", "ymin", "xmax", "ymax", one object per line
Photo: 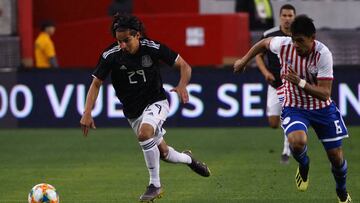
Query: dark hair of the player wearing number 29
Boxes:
[{"xmin": 111, "ymin": 13, "xmax": 146, "ymax": 37}]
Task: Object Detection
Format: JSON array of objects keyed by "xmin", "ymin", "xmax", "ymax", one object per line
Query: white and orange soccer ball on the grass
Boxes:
[{"xmin": 28, "ymin": 183, "xmax": 60, "ymax": 203}]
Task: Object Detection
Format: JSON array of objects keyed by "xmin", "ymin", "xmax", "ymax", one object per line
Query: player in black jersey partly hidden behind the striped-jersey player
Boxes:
[{"xmin": 256, "ymin": 4, "xmax": 296, "ymax": 164}]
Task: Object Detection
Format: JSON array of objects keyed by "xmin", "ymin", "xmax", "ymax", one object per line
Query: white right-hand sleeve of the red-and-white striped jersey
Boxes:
[{"xmin": 317, "ymin": 51, "xmax": 334, "ymax": 80}]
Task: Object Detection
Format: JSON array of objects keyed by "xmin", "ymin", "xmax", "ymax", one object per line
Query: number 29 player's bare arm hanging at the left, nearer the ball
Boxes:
[{"xmin": 80, "ymin": 78, "xmax": 102, "ymax": 137}]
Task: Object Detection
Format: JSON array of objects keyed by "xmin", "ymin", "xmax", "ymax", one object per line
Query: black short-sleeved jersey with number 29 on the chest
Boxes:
[{"xmin": 93, "ymin": 38, "xmax": 178, "ymax": 118}]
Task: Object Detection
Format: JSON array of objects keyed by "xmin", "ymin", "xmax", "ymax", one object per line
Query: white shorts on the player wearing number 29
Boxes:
[{"xmin": 128, "ymin": 99, "xmax": 170, "ymax": 145}]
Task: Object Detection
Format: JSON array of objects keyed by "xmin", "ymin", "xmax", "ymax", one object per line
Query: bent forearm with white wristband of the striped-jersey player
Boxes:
[{"xmin": 285, "ymin": 68, "xmax": 332, "ymax": 101}]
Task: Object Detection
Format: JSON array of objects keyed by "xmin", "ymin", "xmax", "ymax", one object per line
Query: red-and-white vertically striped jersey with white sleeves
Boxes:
[{"xmin": 269, "ymin": 37, "xmax": 333, "ymax": 110}]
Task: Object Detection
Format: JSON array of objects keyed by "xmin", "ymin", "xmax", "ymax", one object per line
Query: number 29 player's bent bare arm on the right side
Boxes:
[{"xmin": 170, "ymin": 55, "xmax": 191, "ymax": 103}]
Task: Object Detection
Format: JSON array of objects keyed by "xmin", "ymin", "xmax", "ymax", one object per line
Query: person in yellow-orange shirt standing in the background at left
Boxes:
[{"xmin": 35, "ymin": 21, "xmax": 59, "ymax": 69}]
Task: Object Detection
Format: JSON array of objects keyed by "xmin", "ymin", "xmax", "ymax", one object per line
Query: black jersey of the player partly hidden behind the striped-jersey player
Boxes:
[{"xmin": 261, "ymin": 26, "xmax": 288, "ymax": 88}]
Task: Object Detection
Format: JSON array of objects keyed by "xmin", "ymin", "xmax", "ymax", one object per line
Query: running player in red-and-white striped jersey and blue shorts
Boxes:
[{"xmin": 234, "ymin": 15, "xmax": 351, "ymax": 203}]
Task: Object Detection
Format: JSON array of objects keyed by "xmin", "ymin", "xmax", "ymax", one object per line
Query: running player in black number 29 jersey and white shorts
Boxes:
[{"xmin": 80, "ymin": 14, "xmax": 210, "ymax": 202}]
